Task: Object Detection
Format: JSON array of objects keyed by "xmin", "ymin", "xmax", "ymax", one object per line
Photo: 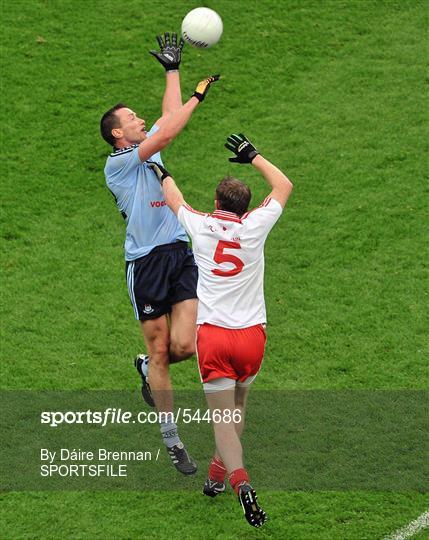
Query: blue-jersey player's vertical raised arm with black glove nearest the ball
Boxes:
[{"xmin": 149, "ymin": 32, "xmax": 184, "ymax": 123}]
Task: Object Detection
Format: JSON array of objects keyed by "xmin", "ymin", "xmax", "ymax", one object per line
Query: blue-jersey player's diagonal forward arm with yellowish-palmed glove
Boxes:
[{"xmin": 139, "ymin": 75, "xmax": 219, "ymax": 161}]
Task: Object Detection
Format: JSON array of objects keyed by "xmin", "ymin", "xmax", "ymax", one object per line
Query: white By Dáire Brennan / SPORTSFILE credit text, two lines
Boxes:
[{"xmin": 40, "ymin": 448, "xmax": 160, "ymax": 477}]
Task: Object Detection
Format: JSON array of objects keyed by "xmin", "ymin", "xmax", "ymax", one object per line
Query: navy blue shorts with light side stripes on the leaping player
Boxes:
[{"xmin": 125, "ymin": 242, "xmax": 198, "ymax": 321}]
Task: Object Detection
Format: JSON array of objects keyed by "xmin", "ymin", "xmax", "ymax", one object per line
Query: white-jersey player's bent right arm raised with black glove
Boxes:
[{"xmin": 225, "ymin": 133, "xmax": 293, "ymax": 207}]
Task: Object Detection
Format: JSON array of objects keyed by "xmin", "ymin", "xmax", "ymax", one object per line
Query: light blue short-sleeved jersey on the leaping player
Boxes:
[{"xmin": 104, "ymin": 125, "xmax": 189, "ymax": 261}]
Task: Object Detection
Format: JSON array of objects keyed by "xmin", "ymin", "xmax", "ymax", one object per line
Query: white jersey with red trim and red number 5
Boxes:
[{"xmin": 178, "ymin": 197, "xmax": 283, "ymax": 328}]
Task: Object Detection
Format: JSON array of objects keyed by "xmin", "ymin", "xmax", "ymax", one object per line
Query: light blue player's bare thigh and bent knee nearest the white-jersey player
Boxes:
[{"xmin": 170, "ymin": 298, "xmax": 198, "ymax": 363}]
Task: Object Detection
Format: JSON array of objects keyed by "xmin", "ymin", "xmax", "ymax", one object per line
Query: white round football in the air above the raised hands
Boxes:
[{"xmin": 182, "ymin": 8, "xmax": 223, "ymax": 48}]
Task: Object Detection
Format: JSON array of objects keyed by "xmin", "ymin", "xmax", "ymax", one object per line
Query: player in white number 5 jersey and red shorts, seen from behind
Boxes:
[{"xmin": 150, "ymin": 134, "xmax": 292, "ymax": 527}]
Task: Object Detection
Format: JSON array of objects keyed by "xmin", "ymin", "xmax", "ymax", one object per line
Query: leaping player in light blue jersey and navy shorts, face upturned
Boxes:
[{"xmin": 100, "ymin": 33, "xmax": 219, "ymax": 475}]
